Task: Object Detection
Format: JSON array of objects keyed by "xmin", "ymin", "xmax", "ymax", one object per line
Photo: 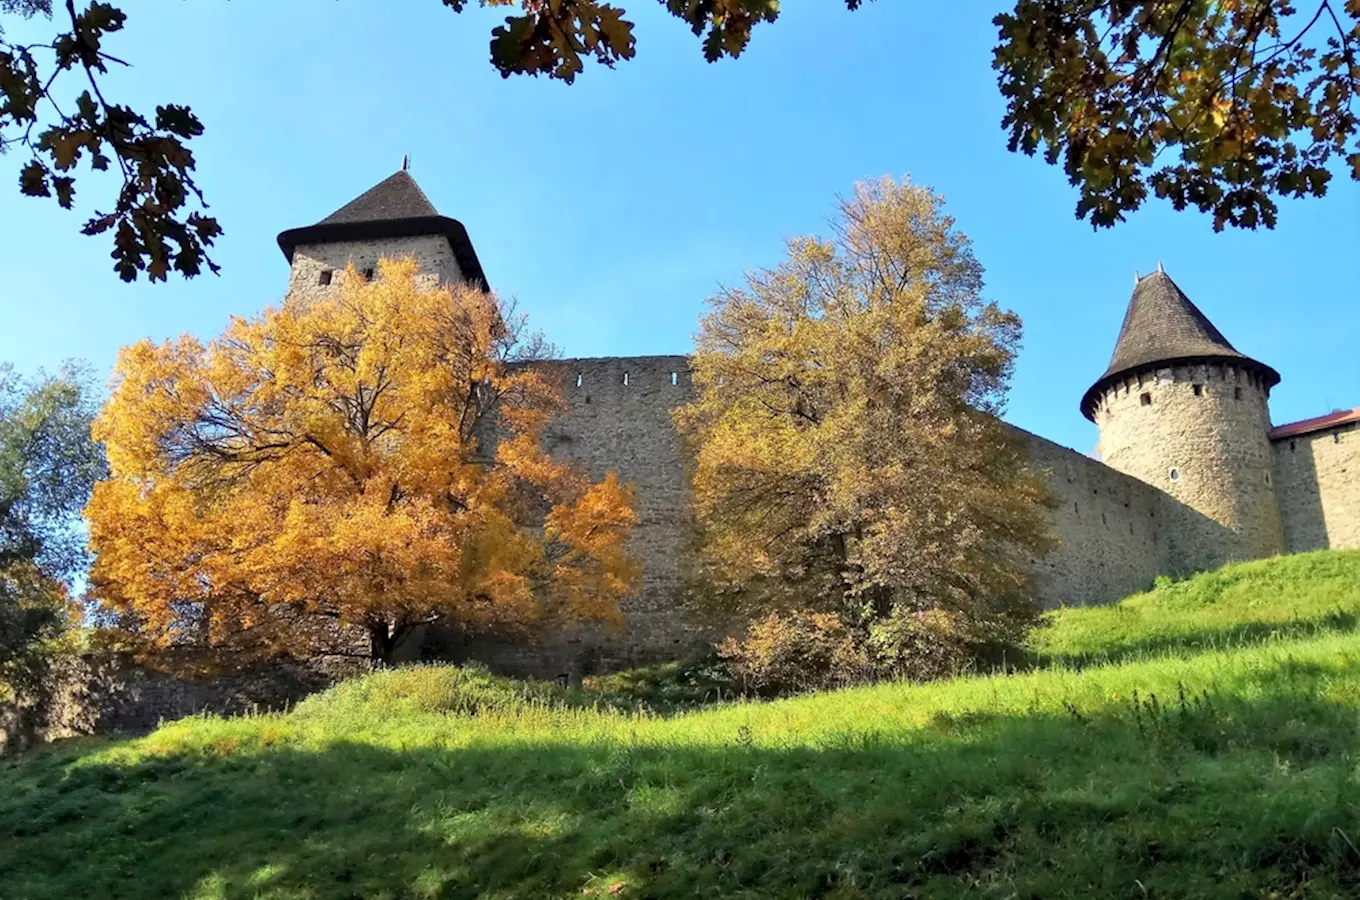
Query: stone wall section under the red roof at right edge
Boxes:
[{"xmin": 1274, "ymin": 423, "xmax": 1360, "ymax": 553}]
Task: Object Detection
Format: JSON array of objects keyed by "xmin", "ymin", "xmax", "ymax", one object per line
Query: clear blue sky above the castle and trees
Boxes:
[{"xmin": 0, "ymin": 0, "xmax": 1360, "ymax": 451}]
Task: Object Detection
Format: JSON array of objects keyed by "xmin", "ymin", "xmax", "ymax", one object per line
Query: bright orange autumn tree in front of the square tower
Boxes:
[{"xmin": 86, "ymin": 260, "xmax": 635, "ymax": 661}]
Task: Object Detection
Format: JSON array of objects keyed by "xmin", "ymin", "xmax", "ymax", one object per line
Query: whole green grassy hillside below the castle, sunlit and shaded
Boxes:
[{"xmin": 0, "ymin": 553, "xmax": 1360, "ymax": 900}]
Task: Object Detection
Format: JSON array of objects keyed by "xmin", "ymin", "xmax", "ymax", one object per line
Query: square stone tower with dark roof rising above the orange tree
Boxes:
[{"xmin": 279, "ymin": 169, "xmax": 487, "ymax": 303}]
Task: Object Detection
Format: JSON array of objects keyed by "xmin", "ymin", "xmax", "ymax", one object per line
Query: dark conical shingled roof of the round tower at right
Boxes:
[{"xmin": 1081, "ymin": 266, "xmax": 1280, "ymax": 419}]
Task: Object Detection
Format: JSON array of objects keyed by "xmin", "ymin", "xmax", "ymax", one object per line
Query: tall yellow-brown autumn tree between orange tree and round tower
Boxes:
[{"xmin": 677, "ymin": 179, "xmax": 1049, "ymax": 687}]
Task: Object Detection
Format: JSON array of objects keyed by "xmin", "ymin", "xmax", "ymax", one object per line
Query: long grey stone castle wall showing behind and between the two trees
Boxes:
[{"xmin": 409, "ymin": 356, "xmax": 1191, "ymax": 678}]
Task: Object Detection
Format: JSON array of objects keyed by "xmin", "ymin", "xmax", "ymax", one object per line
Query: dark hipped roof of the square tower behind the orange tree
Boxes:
[{"xmin": 279, "ymin": 167, "xmax": 487, "ymax": 290}]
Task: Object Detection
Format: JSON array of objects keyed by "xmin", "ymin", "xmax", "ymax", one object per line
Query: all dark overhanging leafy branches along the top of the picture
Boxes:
[{"xmin": 0, "ymin": 0, "xmax": 1360, "ymax": 281}]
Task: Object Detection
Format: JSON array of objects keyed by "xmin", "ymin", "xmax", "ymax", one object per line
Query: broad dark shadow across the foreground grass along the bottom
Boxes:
[{"xmin": 0, "ymin": 662, "xmax": 1360, "ymax": 900}]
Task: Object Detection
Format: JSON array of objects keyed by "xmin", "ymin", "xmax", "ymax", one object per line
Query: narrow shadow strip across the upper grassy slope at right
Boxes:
[{"xmin": 1020, "ymin": 609, "xmax": 1360, "ymax": 669}]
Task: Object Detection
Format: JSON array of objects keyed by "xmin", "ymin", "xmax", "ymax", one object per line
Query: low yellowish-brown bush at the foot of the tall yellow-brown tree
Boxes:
[{"xmin": 719, "ymin": 606, "xmax": 972, "ymax": 696}]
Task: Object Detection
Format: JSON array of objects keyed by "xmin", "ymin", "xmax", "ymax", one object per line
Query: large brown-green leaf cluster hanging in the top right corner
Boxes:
[{"xmin": 994, "ymin": 0, "xmax": 1360, "ymax": 230}]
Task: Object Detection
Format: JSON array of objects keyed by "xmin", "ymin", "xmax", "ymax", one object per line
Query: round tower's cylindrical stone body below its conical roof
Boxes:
[{"xmin": 1096, "ymin": 363, "xmax": 1284, "ymax": 574}]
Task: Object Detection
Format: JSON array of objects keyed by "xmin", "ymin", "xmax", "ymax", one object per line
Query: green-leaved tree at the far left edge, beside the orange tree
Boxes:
[{"xmin": 0, "ymin": 364, "xmax": 105, "ymax": 693}]
